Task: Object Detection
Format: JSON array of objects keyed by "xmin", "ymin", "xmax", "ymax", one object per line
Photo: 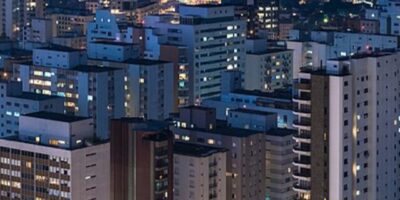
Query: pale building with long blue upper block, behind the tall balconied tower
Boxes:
[{"xmin": 287, "ymin": 30, "xmax": 398, "ymax": 79}]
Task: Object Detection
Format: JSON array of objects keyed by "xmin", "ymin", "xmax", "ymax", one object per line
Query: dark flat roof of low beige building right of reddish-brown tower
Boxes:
[{"xmin": 174, "ymin": 142, "xmax": 227, "ymax": 157}]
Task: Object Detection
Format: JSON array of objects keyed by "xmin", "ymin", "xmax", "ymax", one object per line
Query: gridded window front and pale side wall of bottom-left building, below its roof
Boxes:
[{"xmin": 0, "ymin": 139, "xmax": 110, "ymax": 200}]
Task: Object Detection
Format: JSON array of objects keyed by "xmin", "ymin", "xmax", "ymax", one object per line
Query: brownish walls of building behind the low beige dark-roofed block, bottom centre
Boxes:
[{"xmin": 173, "ymin": 128, "xmax": 265, "ymax": 200}]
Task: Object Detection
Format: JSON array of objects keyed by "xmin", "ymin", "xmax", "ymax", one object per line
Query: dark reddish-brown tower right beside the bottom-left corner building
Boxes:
[{"xmin": 110, "ymin": 118, "xmax": 174, "ymax": 200}]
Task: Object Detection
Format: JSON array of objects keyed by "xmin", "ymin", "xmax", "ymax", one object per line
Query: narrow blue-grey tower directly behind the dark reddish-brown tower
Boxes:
[{"xmin": 125, "ymin": 59, "xmax": 178, "ymax": 120}]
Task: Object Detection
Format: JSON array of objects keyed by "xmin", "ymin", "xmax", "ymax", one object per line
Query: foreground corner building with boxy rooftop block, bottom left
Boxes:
[{"xmin": 0, "ymin": 112, "xmax": 110, "ymax": 200}]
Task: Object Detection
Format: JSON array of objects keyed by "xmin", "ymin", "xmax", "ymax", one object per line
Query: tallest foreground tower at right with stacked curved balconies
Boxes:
[{"xmin": 293, "ymin": 52, "xmax": 400, "ymax": 199}]
